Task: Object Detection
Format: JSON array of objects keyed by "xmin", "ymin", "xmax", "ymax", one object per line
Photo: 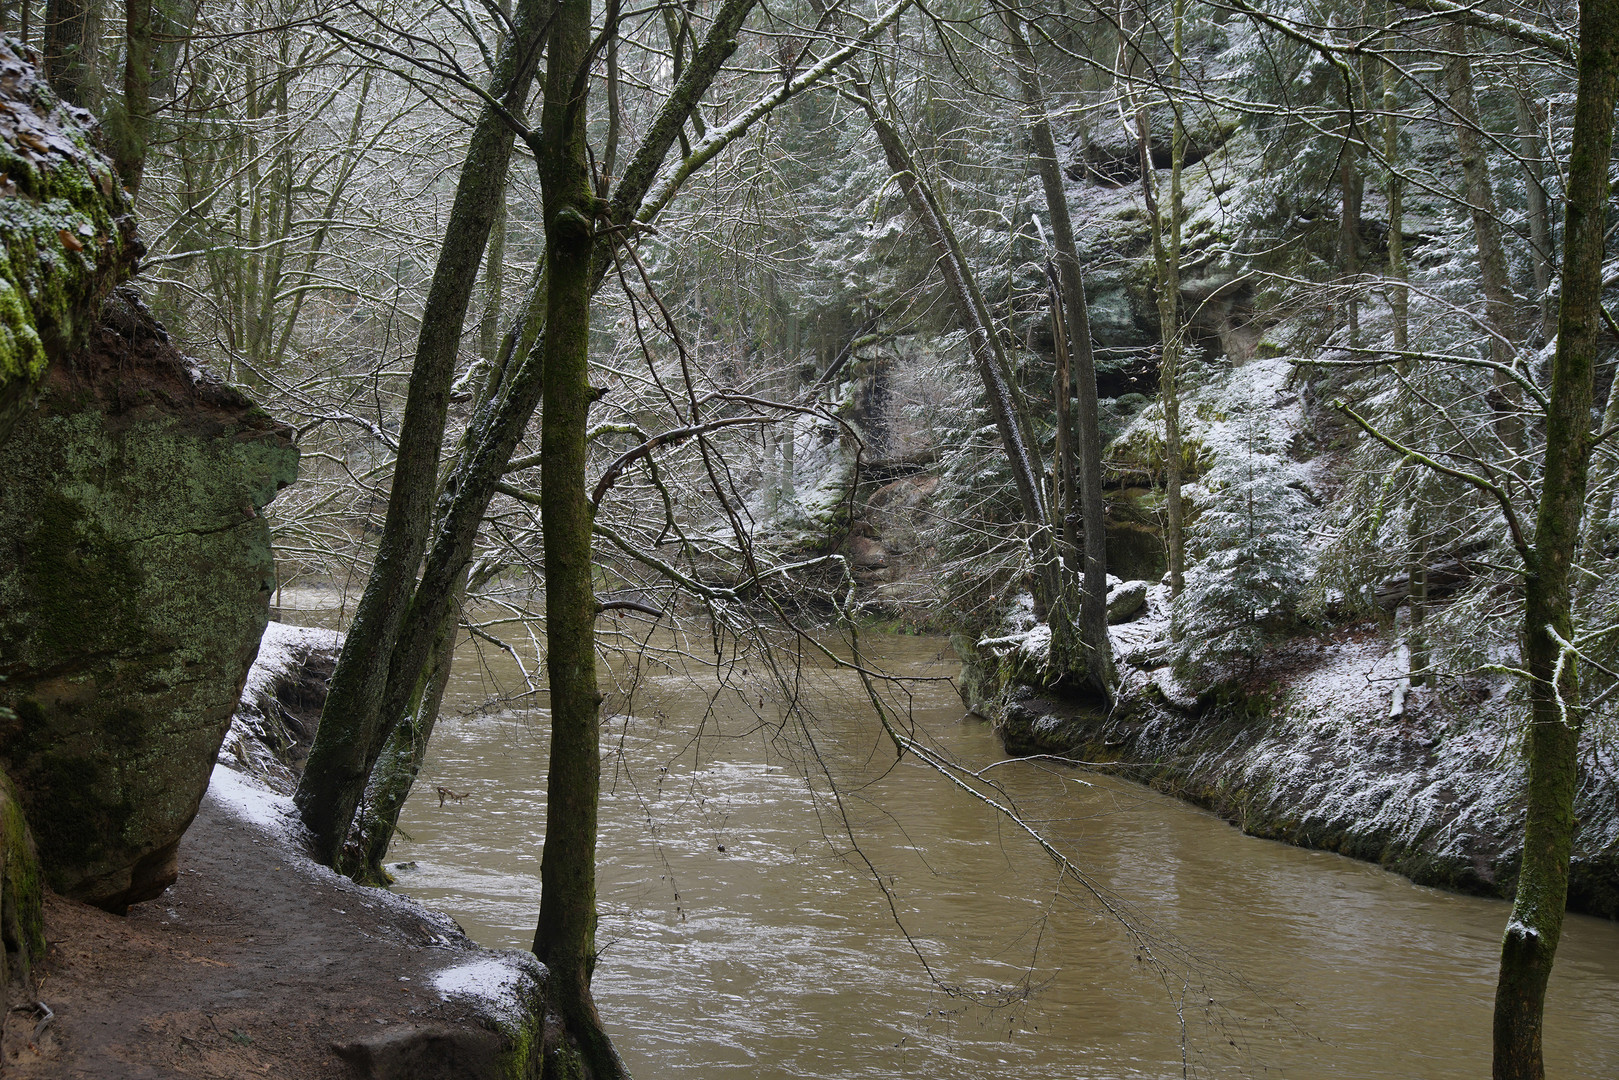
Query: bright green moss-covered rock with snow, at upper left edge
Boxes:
[{"xmin": 0, "ymin": 39, "xmax": 141, "ymax": 442}]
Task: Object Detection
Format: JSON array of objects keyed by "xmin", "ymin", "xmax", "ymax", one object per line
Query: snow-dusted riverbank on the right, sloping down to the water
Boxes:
[{"xmin": 962, "ymin": 586, "xmax": 1619, "ymax": 918}]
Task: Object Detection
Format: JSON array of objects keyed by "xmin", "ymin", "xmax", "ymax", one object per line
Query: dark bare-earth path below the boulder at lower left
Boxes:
[{"xmin": 0, "ymin": 777, "xmax": 531, "ymax": 1080}]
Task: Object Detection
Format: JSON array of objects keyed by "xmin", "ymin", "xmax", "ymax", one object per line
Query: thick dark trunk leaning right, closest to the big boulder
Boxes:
[{"xmin": 296, "ymin": 0, "xmax": 549, "ymax": 866}]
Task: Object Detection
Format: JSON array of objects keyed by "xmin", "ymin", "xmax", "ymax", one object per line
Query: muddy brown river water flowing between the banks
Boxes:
[{"xmin": 275, "ymin": 605, "xmax": 1619, "ymax": 1080}]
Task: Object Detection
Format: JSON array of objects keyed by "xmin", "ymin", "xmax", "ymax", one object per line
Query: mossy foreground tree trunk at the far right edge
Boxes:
[{"xmin": 1494, "ymin": 0, "xmax": 1619, "ymax": 1080}]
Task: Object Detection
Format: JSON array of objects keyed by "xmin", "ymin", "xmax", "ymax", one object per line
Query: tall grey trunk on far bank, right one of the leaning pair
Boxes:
[{"xmin": 1005, "ymin": 10, "xmax": 1115, "ymax": 693}]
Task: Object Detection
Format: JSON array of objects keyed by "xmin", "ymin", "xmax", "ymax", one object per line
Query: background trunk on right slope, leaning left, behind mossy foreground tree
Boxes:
[{"xmin": 1446, "ymin": 23, "xmax": 1523, "ymax": 450}]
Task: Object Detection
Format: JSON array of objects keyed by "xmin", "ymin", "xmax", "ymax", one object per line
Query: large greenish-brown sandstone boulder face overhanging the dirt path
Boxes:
[{"xmin": 0, "ymin": 291, "xmax": 298, "ymax": 910}]
